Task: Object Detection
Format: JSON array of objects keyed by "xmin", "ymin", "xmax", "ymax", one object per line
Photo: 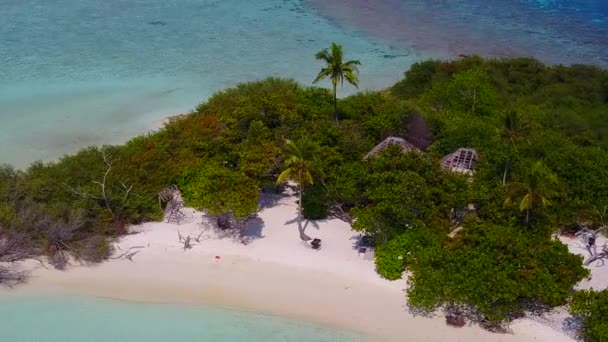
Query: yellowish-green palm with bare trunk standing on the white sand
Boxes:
[{"xmin": 277, "ymin": 136, "xmax": 316, "ymax": 241}]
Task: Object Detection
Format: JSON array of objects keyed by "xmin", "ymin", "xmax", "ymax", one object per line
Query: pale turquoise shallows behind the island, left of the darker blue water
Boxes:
[{"xmin": 0, "ymin": 0, "xmax": 416, "ymax": 166}]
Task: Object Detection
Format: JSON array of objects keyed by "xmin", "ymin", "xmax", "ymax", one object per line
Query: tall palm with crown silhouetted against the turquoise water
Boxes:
[{"xmin": 312, "ymin": 43, "xmax": 361, "ymax": 124}]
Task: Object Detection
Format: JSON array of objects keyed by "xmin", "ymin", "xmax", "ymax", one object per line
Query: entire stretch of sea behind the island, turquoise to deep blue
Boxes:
[{"xmin": 0, "ymin": 0, "xmax": 608, "ymax": 166}]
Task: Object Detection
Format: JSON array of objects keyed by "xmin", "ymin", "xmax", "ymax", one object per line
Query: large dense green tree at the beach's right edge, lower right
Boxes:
[{"xmin": 408, "ymin": 221, "xmax": 589, "ymax": 322}]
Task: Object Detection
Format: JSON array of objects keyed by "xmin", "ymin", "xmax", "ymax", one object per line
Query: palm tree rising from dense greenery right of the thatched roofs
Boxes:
[{"xmin": 505, "ymin": 161, "xmax": 557, "ymax": 225}]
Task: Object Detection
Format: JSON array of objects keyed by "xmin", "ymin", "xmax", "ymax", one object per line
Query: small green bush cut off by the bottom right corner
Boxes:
[{"xmin": 570, "ymin": 289, "xmax": 608, "ymax": 342}]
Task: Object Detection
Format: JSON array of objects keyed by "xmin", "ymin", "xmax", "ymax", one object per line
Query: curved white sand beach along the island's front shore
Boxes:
[{"xmin": 1, "ymin": 191, "xmax": 600, "ymax": 342}]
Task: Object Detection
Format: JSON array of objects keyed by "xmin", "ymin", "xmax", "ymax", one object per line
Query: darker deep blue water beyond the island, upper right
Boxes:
[{"xmin": 310, "ymin": 0, "xmax": 608, "ymax": 67}]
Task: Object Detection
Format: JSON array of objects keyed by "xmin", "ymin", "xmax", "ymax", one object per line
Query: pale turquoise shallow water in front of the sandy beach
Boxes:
[{"xmin": 0, "ymin": 297, "xmax": 369, "ymax": 342}]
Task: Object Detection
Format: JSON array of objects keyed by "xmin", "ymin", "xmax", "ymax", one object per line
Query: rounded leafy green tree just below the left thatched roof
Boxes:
[{"xmin": 352, "ymin": 150, "xmax": 467, "ymax": 244}]
